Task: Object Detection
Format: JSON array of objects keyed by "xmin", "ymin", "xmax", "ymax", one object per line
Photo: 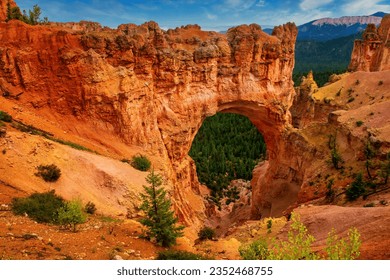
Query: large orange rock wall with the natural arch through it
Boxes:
[{"xmin": 0, "ymin": 8, "xmax": 303, "ymax": 226}]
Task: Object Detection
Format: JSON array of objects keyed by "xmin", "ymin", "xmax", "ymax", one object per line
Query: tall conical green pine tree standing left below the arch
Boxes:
[{"xmin": 140, "ymin": 171, "xmax": 184, "ymax": 247}]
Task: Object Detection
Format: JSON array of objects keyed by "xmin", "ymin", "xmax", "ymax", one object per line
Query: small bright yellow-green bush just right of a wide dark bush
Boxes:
[{"xmin": 58, "ymin": 200, "xmax": 87, "ymax": 232}]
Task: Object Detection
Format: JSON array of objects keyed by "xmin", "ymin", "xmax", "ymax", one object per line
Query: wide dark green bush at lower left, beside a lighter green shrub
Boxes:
[{"xmin": 11, "ymin": 190, "xmax": 65, "ymax": 223}]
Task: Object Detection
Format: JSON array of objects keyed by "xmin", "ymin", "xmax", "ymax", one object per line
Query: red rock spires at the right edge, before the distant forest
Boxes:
[{"xmin": 348, "ymin": 15, "xmax": 390, "ymax": 72}]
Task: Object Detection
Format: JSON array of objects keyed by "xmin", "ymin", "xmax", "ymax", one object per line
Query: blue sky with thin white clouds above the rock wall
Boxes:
[{"xmin": 15, "ymin": 0, "xmax": 390, "ymax": 31}]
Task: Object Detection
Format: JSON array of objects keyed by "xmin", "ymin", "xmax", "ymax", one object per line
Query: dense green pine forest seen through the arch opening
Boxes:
[{"xmin": 189, "ymin": 113, "xmax": 266, "ymax": 205}]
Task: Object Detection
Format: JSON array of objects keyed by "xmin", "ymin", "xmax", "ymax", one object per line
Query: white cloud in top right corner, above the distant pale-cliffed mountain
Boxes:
[{"xmin": 341, "ymin": 0, "xmax": 390, "ymax": 15}]
